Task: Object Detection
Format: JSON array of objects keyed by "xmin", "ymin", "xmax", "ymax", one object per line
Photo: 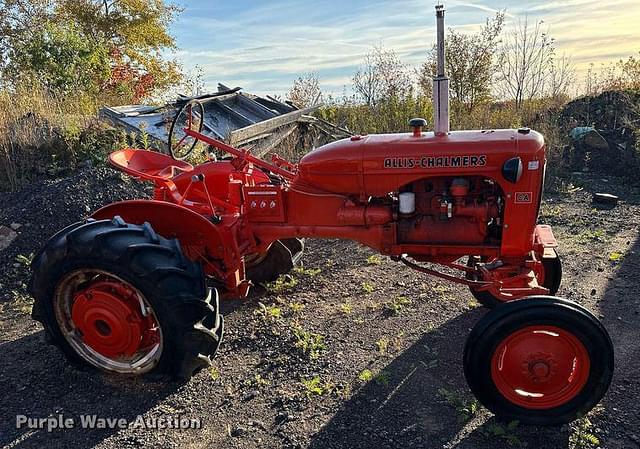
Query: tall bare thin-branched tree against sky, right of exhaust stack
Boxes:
[{"xmin": 498, "ymin": 17, "xmax": 555, "ymax": 109}]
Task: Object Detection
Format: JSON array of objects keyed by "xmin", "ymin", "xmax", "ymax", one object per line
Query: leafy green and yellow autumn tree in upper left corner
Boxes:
[{"xmin": 0, "ymin": 0, "xmax": 181, "ymax": 102}]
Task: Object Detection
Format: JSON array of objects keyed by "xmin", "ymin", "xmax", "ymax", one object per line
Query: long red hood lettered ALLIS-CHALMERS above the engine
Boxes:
[{"xmin": 295, "ymin": 129, "xmax": 544, "ymax": 197}]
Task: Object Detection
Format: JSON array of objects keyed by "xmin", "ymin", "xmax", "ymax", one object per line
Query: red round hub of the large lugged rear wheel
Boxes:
[{"xmin": 71, "ymin": 281, "xmax": 158, "ymax": 358}]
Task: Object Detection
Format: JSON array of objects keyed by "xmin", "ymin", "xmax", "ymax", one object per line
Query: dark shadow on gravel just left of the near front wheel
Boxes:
[{"xmin": 309, "ymin": 308, "xmax": 568, "ymax": 449}]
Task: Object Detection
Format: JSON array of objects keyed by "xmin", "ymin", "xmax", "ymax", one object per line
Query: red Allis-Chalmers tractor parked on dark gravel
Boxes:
[{"xmin": 31, "ymin": 7, "xmax": 613, "ymax": 424}]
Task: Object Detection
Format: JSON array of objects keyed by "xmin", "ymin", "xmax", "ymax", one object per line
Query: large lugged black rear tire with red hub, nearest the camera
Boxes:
[{"xmin": 31, "ymin": 217, "xmax": 224, "ymax": 380}]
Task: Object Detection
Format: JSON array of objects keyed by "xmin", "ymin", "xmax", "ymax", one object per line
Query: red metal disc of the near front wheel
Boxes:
[{"xmin": 491, "ymin": 326, "xmax": 590, "ymax": 409}]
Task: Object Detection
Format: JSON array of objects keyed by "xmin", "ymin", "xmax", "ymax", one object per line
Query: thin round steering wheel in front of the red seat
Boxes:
[{"xmin": 167, "ymin": 100, "xmax": 204, "ymax": 161}]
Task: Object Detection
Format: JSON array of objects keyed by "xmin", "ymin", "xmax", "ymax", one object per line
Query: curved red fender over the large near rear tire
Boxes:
[{"xmin": 91, "ymin": 200, "xmax": 249, "ymax": 297}]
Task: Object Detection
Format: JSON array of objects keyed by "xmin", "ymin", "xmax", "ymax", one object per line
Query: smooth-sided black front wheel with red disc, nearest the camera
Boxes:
[{"xmin": 464, "ymin": 296, "xmax": 613, "ymax": 425}]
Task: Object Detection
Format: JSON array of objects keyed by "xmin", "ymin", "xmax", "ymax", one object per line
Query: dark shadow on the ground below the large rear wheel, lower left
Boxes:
[{"xmin": 0, "ymin": 331, "xmax": 178, "ymax": 448}]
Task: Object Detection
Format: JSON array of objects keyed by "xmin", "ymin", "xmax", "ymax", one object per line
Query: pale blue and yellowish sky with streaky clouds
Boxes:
[{"xmin": 172, "ymin": 0, "xmax": 640, "ymax": 96}]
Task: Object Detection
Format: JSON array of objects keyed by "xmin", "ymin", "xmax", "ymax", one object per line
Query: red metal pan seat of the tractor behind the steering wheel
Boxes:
[{"xmin": 109, "ymin": 148, "xmax": 193, "ymax": 183}]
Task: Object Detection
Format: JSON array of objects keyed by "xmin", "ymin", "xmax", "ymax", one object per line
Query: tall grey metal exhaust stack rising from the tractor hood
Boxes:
[{"xmin": 433, "ymin": 5, "xmax": 449, "ymax": 136}]
